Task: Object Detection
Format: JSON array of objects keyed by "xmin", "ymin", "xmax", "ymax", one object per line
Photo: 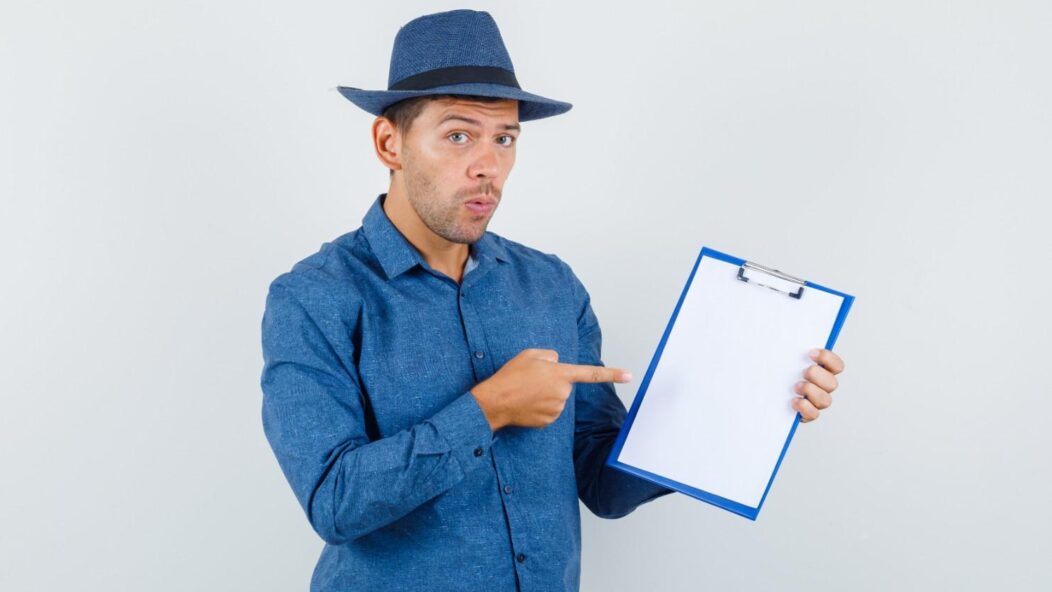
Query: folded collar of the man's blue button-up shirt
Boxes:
[{"xmin": 362, "ymin": 193, "xmax": 508, "ymax": 280}]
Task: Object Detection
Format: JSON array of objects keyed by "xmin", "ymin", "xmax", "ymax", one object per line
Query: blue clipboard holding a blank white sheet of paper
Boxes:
[{"xmin": 606, "ymin": 246, "xmax": 854, "ymax": 520}]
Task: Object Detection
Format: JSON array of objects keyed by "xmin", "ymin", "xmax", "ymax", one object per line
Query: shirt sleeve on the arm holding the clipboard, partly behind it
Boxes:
[{"xmin": 563, "ymin": 262, "xmax": 673, "ymax": 518}]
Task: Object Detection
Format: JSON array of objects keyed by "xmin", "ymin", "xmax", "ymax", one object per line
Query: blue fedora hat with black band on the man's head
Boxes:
[{"xmin": 337, "ymin": 9, "xmax": 573, "ymax": 121}]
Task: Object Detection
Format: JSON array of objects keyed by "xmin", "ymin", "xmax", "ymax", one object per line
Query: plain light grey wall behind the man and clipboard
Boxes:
[{"xmin": 0, "ymin": 0, "xmax": 1052, "ymax": 591}]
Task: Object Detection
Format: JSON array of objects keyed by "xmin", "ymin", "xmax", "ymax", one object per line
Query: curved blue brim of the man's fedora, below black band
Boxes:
[{"xmin": 337, "ymin": 82, "xmax": 573, "ymax": 121}]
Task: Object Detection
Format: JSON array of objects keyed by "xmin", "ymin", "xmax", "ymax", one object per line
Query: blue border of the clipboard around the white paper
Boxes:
[{"xmin": 606, "ymin": 246, "xmax": 854, "ymax": 520}]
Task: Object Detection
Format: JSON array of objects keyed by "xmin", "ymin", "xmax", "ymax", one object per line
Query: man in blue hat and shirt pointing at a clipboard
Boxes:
[{"xmin": 261, "ymin": 6, "xmax": 843, "ymax": 591}]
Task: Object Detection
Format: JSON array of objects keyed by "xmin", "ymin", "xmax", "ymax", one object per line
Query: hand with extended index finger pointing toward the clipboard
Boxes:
[{"xmin": 471, "ymin": 349, "xmax": 632, "ymax": 432}]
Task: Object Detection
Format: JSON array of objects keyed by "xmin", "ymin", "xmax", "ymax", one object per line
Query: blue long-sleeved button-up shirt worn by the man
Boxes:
[{"xmin": 261, "ymin": 193, "xmax": 671, "ymax": 591}]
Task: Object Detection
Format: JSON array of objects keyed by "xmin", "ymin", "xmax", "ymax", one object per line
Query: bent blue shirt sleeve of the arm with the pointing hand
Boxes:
[{"xmin": 260, "ymin": 281, "xmax": 493, "ymax": 545}]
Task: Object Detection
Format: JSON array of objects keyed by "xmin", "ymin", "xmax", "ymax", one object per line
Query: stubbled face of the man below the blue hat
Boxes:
[{"xmin": 402, "ymin": 98, "xmax": 520, "ymax": 244}]
